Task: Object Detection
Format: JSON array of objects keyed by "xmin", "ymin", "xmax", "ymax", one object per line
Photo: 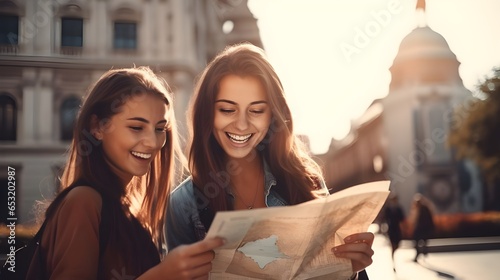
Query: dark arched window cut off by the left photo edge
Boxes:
[{"xmin": 0, "ymin": 93, "xmax": 17, "ymax": 141}]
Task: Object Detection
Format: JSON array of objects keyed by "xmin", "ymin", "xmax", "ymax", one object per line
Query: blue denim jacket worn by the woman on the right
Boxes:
[{"xmin": 165, "ymin": 161, "xmax": 328, "ymax": 250}]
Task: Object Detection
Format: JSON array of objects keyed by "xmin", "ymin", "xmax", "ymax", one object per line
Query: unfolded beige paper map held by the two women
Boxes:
[{"xmin": 207, "ymin": 181, "xmax": 390, "ymax": 280}]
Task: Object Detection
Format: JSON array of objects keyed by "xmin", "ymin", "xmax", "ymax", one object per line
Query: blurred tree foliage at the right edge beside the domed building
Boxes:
[{"xmin": 448, "ymin": 67, "xmax": 500, "ymax": 184}]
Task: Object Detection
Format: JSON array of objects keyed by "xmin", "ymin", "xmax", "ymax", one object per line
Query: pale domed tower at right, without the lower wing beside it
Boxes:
[{"xmin": 381, "ymin": 22, "xmax": 481, "ymax": 212}]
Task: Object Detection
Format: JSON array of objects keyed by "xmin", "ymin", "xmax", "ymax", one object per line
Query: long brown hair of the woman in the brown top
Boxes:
[{"xmin": 54, "ymin": 67, "xmax": 182, "ymax": 244}]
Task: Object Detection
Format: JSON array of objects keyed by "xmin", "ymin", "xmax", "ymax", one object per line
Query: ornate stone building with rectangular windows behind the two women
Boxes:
[{"xmin": 0, "ymin": 0, "xmax": 262, "ymax": 223}]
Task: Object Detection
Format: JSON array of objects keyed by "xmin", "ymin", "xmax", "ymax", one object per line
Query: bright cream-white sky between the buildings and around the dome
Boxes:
[{"xmin": 248, "ymin": 0, "xmax": 500, "ymax": 153}]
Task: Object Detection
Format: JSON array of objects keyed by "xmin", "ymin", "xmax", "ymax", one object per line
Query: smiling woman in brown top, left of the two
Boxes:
[{"xmin": 28, "ymin": 67, "xmax": 223, "ymax": 279}]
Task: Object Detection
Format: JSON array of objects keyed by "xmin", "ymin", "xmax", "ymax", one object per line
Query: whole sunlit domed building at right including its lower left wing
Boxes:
[{"xmin": 320, "ymin": 1, "xmax": 483, "ymax": 213}]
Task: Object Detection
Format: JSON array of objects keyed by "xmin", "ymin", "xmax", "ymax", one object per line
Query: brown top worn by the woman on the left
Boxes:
[{"xmin": 36, "ymin": 187, "xmax": 160, "ymax": 279}]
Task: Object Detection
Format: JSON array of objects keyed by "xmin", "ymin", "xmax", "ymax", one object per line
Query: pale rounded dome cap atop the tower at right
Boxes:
[{"xmin": 394, "ymin": 26, "xmax": 456, "ymax": 63}]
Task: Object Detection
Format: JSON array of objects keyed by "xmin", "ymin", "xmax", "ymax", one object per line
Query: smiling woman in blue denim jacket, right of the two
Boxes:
[{"xmin": 166, "ymin": 44, "xmax": 374, "ymax": 279}]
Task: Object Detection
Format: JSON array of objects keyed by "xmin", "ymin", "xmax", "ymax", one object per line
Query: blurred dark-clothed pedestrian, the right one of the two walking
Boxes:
[{"xmin": 412, "ymin": 193, "xmax": 436, "ymax": 262}]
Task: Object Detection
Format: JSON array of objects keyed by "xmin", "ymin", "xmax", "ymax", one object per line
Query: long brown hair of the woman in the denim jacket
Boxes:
[{"xmin": 188, "ymin": 43, "xmax": 322, "ymax": 211}]
